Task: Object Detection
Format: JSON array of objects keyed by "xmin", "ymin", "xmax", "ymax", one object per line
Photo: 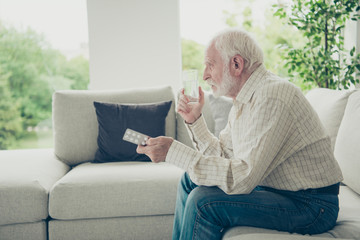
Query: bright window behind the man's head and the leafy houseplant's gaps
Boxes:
[{"xmin": 180, "ymin": 0, "xmax": 360, "ymax": 93}]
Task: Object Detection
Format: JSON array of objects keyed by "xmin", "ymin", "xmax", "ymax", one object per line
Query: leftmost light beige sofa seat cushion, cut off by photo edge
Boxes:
[{"xmin": 0, "ymin": 149, "xmax": 69, "ymax": 225}]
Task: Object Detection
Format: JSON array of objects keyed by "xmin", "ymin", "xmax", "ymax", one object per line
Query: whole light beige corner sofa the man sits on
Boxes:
[{"xmin": 0, "ymin": 87, "xmax": 360, "ymax": 240}]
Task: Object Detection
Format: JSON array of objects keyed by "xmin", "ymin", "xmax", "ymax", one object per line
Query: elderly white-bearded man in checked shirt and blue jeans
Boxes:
[{"xmin": 137, "ymin": 29, "xmax": 342, "ymax": 240}]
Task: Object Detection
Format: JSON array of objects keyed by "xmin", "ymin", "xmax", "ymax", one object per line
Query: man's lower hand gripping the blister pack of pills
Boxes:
[{"xmin": 136, "ymin": 136, "xmax": 174, "ymax": 163}]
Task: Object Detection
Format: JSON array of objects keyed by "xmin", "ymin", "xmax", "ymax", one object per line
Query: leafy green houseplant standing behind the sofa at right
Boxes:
[{"xmin": 274, "ymin": 0, "xmax": 360, "ymax": 89}]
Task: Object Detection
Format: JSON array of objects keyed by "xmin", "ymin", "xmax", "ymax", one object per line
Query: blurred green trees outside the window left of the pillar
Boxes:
[{"xmin": 0, "ymin": 22, "xmax": 89, "ymax": 149}]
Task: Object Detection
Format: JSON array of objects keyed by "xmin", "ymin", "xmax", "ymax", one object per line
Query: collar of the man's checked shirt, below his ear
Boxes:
[{"xmin": 234, "ymin": 64, "xmax": 267, "ymax": 104}]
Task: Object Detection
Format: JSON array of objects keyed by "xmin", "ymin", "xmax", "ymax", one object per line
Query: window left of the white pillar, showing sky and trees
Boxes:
[{"xmin": 0, "ymin": 0, "xmax": 89, "ymax": 149}]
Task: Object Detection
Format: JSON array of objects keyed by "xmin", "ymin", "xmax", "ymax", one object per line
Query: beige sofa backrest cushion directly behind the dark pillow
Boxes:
[{"xmin": 53, "ymin": 86, "xmax": 176, "ymax": 166}]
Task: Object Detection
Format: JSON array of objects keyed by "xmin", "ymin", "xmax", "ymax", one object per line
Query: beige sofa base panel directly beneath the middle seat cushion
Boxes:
[{"xmin": 49, "ymin": 215, "xmax": 174, "ymax": 240}]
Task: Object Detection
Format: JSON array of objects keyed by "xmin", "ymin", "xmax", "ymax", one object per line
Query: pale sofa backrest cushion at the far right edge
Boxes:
[{"xmin": 334, "ymin": 90, "xmax": 360, "ymax": 194}]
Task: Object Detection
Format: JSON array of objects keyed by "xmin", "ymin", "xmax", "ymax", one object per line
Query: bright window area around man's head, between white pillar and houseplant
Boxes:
[{"xmin": 180, "ymin": 0, "xmax": 302, "ymax": 90}]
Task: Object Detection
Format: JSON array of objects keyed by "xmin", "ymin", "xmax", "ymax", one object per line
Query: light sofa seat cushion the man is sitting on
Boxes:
[{"xmin": 223, "ymin": 186, "xmax": 360, "ymax": 240}]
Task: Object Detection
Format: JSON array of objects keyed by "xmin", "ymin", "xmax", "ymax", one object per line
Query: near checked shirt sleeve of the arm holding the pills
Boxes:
[{"xmin": 166, "ymin": 99, "xmax": 294, "ymax": 194}]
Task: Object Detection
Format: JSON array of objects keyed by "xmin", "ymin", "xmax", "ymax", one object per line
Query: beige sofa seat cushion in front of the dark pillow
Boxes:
[{"xmin": 49, "ymin": 162, "xmax": 183, "ymax": 220}]
